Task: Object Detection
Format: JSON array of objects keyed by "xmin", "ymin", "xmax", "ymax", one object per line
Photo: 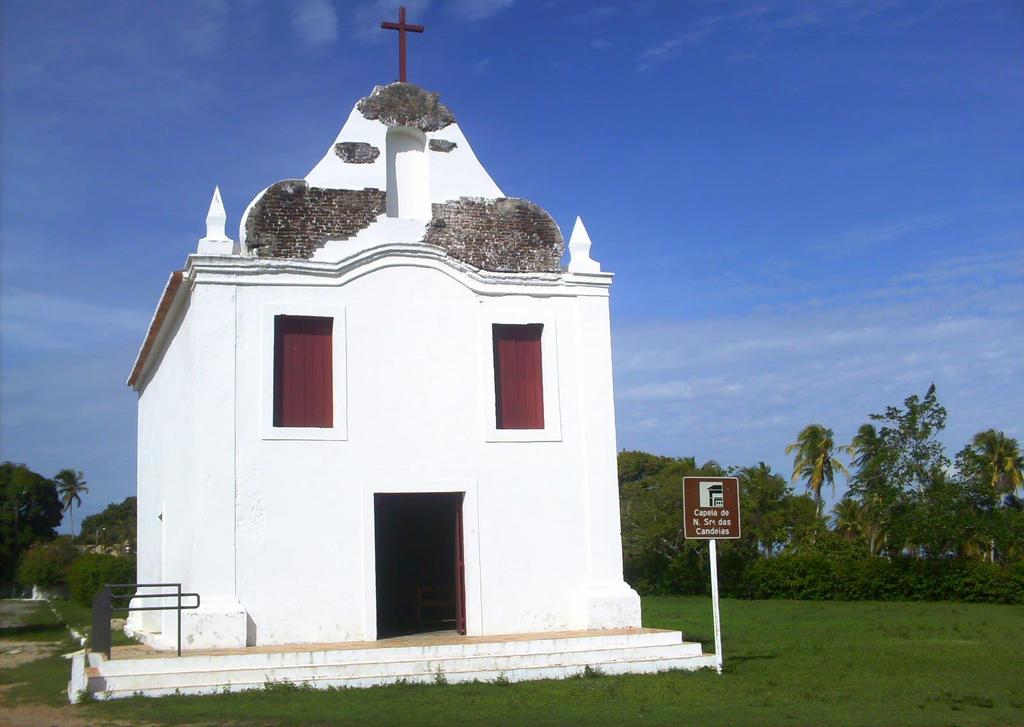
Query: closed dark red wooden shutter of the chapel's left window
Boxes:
[{"xmin": 273, "ymin": 315, "xmax": 334, "ymax": 427}]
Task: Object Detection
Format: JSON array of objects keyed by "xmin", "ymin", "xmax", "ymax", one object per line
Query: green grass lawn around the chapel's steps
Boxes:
[{"xmin": 0, "ymin": 597, "xmax": 1024, "ymax": 725}]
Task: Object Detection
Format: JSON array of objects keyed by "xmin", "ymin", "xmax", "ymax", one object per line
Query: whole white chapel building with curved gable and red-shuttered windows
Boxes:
[{"xmin": 128, "ymin": 83, "xmax": 640, "ymax": 649}]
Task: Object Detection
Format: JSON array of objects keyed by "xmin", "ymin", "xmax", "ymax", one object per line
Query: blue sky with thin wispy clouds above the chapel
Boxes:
[{"xmin": 0, "ymin": 0, "xmax": 1024, "ymax": 524}]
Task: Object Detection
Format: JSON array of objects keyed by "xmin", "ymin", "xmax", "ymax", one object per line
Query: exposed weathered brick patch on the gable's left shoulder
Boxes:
[{"xmin": 246, "ymin": 179, "xmax": 386, "ymax": 258}]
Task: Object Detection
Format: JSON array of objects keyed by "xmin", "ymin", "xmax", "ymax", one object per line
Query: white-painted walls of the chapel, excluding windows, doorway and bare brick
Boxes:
[{"xmin": 130, "ymin": 82, "xmax": 640, "ymax": 648}]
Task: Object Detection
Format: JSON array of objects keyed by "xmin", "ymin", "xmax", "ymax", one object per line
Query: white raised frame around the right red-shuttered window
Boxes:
[{"xmin": 478, "ymin": 304, "xmax": 562, "ymax": 442}]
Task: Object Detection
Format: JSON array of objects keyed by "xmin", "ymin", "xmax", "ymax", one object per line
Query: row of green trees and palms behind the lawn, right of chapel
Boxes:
[{"xmin": 618, "ymin": 386, "xmax": 1024, "ymax": 600}]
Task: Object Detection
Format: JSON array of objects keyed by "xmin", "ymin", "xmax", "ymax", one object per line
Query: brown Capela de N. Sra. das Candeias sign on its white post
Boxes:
[{"xmin": 683, "ymin": 477, "xmax": 739, "ymax": 674}]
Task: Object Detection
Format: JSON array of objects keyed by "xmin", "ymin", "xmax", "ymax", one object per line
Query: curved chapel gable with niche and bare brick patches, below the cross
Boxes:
[{"xmin": 234, "ymin": 82, "xmax": 564, "ymax": 272}]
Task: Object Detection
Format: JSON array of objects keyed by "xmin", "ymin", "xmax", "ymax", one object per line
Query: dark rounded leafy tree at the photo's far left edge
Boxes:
[{"xmin": 0, "ymin": 462, "xmax": 60, "ymax": 583}]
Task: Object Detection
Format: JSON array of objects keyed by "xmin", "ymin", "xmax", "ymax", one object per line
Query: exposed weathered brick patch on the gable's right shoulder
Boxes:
[{"xmin": 423, "ymin": 197, "xmax": 564, "ymax": 272}]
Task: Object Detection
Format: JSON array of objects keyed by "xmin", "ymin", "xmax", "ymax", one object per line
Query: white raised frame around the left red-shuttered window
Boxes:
[{"xmin": 260, "ymin": 303, "xmax": 348, "ymax": 441}]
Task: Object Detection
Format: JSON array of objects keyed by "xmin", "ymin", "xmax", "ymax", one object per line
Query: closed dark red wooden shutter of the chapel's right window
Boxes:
[{"xmin": 494, "ymin": 324, "xmax": 544, "ymax": 429}]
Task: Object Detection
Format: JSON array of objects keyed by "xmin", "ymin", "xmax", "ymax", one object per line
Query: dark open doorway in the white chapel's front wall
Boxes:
[{"xmin": 374, "ymin": 493, "xmax": 466, "ymax": 639}]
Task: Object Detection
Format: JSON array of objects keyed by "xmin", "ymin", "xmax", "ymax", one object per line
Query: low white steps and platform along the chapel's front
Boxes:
[{"xmin": 69, "ymin": 629, "xmax": 715, "ymax": 701}]
